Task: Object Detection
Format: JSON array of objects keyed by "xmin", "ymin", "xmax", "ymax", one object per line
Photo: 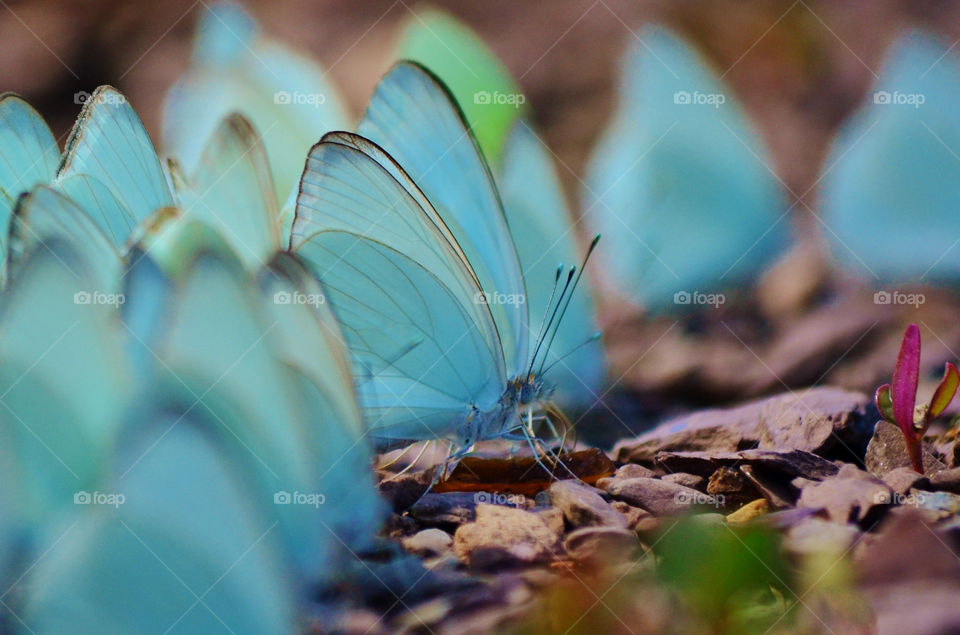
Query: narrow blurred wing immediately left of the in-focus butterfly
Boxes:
[{"xmin": 260, "ymin": 253, "xmax": 385, "ymax": 552}]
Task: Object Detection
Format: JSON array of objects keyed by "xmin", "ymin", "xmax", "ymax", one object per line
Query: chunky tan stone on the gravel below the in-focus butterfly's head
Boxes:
[{"xmin": 453, "ymin": 504, "xmax": 563, "ymax": 569}]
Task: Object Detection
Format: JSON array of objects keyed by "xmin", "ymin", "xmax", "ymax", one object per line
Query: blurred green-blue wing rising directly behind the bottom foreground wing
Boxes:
[{"xmin": 156, "ymin": 251, "xmax": 334, "ymax": 580}]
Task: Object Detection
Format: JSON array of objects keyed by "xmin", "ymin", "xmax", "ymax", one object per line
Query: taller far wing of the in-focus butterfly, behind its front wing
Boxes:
[{"xmin": 358, "ymin": 62, "xmax": 529, "ymax": 375}]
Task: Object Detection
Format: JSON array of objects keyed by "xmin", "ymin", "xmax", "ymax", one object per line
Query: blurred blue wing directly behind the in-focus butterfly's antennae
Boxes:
[{"xmin": 499, "ymin": 120, "xmax": 604, "ymax": 407}]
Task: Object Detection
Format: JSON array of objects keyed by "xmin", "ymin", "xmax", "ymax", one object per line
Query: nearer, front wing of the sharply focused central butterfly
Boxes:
[{"xmin": 291, "ymin": 136, "xmax": 506, "ymax": 439}]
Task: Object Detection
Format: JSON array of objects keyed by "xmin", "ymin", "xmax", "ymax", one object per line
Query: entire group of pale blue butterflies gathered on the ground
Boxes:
[{"xmin": 0, "ymin": 6, "xmax": 960, "ymax": 633}]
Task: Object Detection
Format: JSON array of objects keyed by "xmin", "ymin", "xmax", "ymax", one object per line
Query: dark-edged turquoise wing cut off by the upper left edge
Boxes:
[{"xmin": 0, "ymin": 93, "xmax": 60, "ymax": 258}]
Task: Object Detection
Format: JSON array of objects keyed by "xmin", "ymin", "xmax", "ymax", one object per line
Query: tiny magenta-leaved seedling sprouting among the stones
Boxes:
[{"xmin": 874, "ymin": 324, "xmax": 960, "ymax": 474}]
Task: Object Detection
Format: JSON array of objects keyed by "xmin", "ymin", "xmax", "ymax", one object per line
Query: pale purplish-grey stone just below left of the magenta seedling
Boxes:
[{"xmin": 797, "ymin": 464, "xmax": 892, "ymax": 523}]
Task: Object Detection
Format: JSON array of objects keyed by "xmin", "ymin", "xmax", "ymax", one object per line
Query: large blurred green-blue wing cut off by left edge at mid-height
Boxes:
[{"xmin": 0, "ymin": 240, "xmax": 129, "ymax": 520}]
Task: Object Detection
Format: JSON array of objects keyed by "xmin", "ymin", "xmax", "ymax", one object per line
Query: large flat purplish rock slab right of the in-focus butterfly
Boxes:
[{"xmin": 614, "ymin": 387, "xmax": 872, "ymax": 463}]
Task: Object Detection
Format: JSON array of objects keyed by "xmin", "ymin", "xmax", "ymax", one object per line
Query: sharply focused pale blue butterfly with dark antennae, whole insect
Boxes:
[{"xmin": 291, "ymin": 63, "xmax": 595, "ymax": 472}]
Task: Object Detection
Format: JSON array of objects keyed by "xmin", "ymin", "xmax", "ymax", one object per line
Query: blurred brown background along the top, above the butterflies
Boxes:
[{"xmin": 0, "ymin": 0, "xmax": 960, "ymax": 209}]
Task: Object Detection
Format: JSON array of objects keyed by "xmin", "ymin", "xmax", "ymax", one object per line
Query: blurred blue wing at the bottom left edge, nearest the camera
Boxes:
[{"xmin": 26, "ymin": 412, "xmax": 300, "ymax": 635}]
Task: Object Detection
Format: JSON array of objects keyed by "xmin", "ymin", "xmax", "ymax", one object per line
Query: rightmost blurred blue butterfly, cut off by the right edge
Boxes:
[{"xmin": 821, "ymin": 31, "xmax": 960, "ymax": 282}]
